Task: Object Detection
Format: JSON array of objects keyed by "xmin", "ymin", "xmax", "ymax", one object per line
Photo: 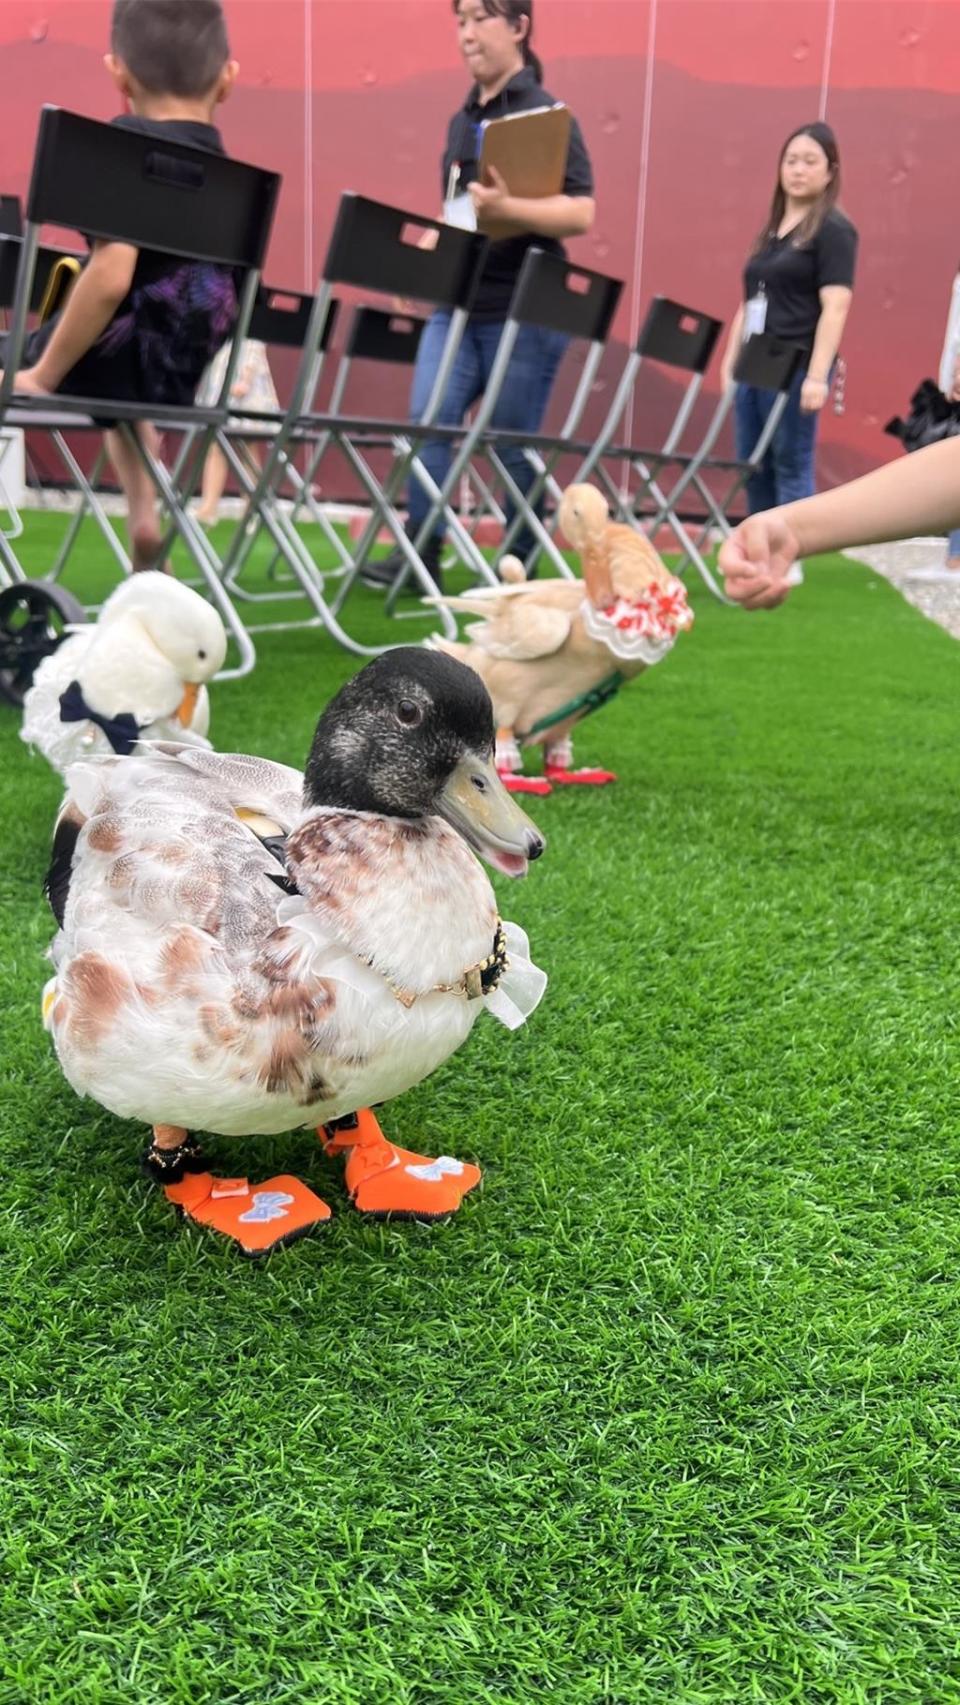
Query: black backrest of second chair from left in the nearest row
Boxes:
[{"xmin": 324, "ymin": 191, "xmax": 488, "ymax": 309}]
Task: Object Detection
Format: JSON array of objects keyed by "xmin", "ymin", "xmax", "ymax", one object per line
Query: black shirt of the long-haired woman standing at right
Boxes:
[{"xmin": 743, "ymin": 208, "xmax": 858, "ymax": 348}]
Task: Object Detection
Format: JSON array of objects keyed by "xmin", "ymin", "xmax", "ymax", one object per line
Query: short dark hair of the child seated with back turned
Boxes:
[{"xmin": 111, "ymin": 0, "xmax": 230, "ymax": 101}]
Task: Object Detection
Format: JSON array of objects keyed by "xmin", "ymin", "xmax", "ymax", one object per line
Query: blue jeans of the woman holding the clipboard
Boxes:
[{"xmin": 408, "ymin": 310, "xmax": 568, "ymax": 559}]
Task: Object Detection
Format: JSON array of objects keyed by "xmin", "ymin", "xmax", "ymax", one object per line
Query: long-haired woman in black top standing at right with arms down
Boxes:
[{"xmin": 721, "ymin": 123, "xmax": 858, "ymax": 513}]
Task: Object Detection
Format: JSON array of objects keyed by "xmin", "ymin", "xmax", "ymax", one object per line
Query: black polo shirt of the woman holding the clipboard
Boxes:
[{"xmin": 440, "ymin": 65, "xmax": 593, "ymax": 321}]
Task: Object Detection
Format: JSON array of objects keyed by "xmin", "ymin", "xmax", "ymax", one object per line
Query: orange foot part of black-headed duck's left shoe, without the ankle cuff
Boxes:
[{"xmin": 164, "ymin": 1173, "xmax": 331, "ymax": 1255}]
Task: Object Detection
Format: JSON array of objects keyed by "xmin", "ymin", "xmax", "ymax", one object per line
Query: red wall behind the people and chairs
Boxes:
[{"xmin": 0, "ymin": 0, "xmax": 960, "ymax": 481}]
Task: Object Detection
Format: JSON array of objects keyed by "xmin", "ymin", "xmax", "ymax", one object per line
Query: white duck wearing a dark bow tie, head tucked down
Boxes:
[{"xmin": 20, "ymin": 569, "xmax": 227, "ymax": 774}]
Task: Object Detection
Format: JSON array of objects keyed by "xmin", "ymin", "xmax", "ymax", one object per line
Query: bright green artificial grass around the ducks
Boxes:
[{"xmin": 0, "ymin": 518, "xmax": 960, "ymax": 1705}]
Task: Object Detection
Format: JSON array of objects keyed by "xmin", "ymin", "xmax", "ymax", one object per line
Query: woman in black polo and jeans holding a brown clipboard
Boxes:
[{"xmin": 361, "ymin": 0, "xmax": 593, "ymax": 587}]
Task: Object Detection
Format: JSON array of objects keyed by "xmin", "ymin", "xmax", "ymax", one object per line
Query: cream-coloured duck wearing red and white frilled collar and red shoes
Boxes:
[{"xmin": 428, "ymin": 486, "xmax": 694, "ymax": 793}]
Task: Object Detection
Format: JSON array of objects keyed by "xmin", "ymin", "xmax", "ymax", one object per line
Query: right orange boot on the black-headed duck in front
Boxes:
[{"xmin": 317, "ymin": 1107, "xmax": 483, "ymax": 1219}]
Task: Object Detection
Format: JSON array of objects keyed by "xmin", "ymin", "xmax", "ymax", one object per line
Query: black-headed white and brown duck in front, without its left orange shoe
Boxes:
[{"xmin": 44, "ymin": 648, "xmax": 546, "ymax": 1229}]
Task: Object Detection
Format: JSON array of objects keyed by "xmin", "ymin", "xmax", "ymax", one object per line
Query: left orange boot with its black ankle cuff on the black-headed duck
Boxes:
[{"xmin": 143, "ymin": 1125, "xmax": 331, "ymax": 1255}]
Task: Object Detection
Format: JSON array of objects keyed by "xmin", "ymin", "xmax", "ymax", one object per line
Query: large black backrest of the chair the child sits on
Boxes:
[{"xmin": 27, "ymin": 106, "xmax": 280, "ymax": 271}]
